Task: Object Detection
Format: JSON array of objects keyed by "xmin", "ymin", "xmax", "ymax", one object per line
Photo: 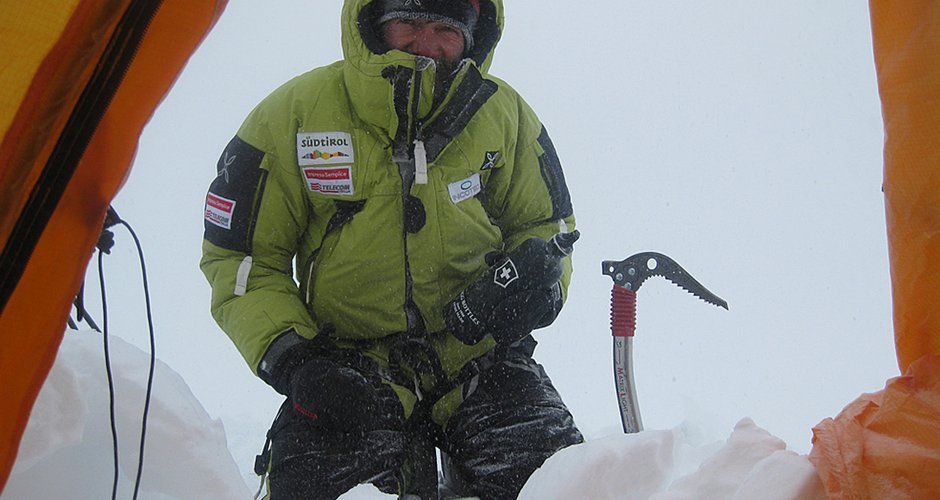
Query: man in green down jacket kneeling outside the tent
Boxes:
[{"xmin": 201, "ymin": 0, "xmax": 582, "ymax": 498}]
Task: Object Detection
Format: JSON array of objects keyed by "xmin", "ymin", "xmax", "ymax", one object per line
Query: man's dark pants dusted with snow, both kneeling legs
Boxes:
[{"xmin": 269, "ymin": 338, "xmax": 583, "ymax": 500}]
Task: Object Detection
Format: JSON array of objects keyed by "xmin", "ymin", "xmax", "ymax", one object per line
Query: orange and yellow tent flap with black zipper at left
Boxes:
[{"xmin": 0, "ymin": 0, "xmax": 226, "ymax": 489}]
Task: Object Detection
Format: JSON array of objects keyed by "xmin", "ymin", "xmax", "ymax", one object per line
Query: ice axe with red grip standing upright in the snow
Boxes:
[{"xmin": 602, "ymin": 252, "xmax": 728, "ymax": 434}]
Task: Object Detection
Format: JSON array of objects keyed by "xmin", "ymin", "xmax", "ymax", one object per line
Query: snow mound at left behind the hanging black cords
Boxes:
[{"xmin": 2, "ymin": 331, "xmax": 252, "ymax": 499}]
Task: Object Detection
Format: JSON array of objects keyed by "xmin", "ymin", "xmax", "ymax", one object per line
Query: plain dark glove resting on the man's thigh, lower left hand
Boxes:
[{"xmin": 258, "ymin": 331, "xmax": 404, "ymax": 432}]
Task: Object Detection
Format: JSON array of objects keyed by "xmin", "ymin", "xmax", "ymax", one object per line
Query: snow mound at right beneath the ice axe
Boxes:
[{"xmin": 519, "ymin": 418, "xmax": 826, "ymax": 500}]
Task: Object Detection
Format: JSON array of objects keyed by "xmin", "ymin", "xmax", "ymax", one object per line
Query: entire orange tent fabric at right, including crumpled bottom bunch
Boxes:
[{"xmin": 810, "ymin": 0, "xmax": 940, "ymax": 499}]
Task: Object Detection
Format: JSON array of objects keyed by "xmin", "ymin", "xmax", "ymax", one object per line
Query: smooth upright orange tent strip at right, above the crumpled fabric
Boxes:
[{"xmin": 871, "ymin": 0, "xmax": 940, "ymax": 373}]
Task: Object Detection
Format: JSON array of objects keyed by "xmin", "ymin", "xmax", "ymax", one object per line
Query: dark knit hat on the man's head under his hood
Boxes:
[{"xmin": 378, "ymin": 0, "xmax": 480, "ymax": 49}]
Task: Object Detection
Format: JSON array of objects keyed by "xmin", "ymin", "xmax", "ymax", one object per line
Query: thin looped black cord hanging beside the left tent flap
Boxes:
[{"xmin": 98, "ymin": 207, "xmax": 157, "ymax": 500}]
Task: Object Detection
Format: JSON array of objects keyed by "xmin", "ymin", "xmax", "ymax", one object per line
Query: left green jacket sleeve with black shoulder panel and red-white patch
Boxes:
[{"xmin": 200, "ymin": 97, "xmax": 316, "ymax": 373}]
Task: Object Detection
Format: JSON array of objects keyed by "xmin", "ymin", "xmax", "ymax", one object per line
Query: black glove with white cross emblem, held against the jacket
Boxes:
[{"xmin": 444, "ymin": 231, "xmax": 580, "ymax": 345}]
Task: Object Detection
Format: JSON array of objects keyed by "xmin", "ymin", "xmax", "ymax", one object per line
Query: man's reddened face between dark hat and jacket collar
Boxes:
[{"xmin": 383, "ymin": 19, "xmax": 464, "ymax": 66}]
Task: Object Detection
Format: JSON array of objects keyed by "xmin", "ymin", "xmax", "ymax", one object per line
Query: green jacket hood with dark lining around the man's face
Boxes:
[{"xmin": 341, "ymin": 0, "xmax": 503, "ymax": 135}]
